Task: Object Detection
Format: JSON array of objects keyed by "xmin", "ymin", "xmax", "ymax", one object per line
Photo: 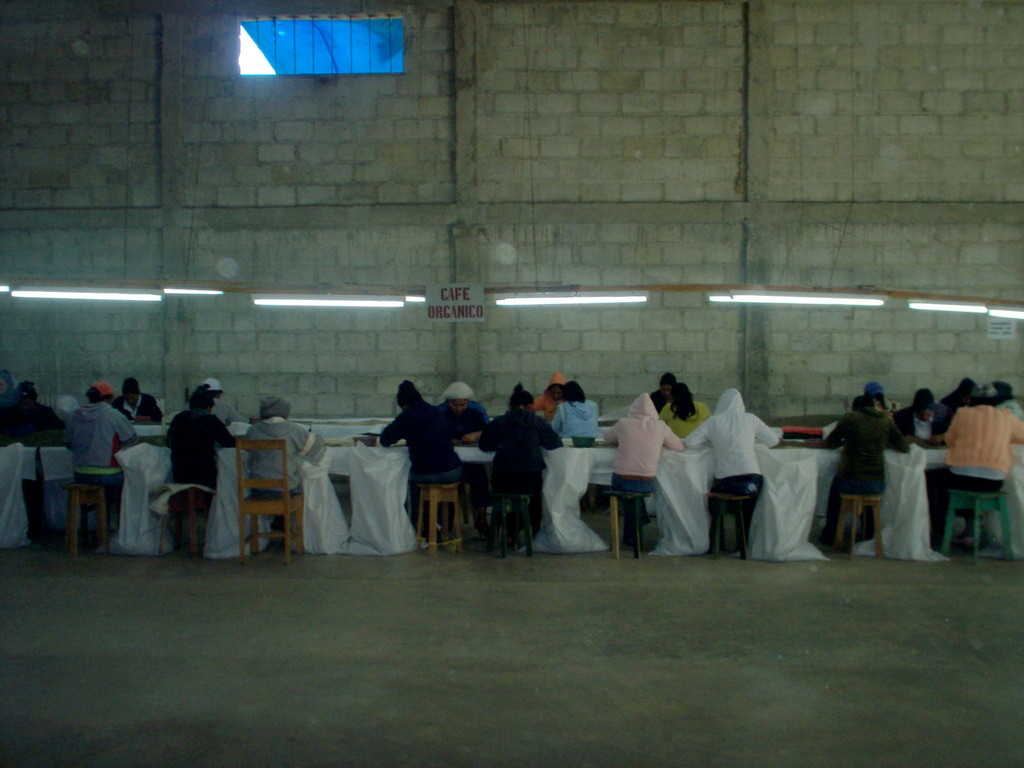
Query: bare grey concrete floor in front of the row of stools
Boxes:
[{"xmin": 0, "ymin": 515, "xmax": 1024, "ymax": 768}]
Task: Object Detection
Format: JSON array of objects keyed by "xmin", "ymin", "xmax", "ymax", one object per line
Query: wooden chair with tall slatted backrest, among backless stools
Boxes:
[{"xmin": 234, "ymin": 437, "xmax": 304, "ymax": 564}]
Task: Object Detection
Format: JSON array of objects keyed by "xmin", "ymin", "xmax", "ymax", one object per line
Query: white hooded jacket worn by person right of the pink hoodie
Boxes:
[{"xmin": 685, "ymin": 389, "xmax": 778, "ymax": 479}]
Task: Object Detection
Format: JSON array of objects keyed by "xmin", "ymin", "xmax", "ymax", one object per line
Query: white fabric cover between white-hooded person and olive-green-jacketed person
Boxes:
[{"xmin": 746, "ymin": 445, "xmax": 828, "ymax": 562}]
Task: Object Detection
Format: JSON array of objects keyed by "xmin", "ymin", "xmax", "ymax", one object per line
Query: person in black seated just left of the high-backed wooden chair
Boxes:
[{"xmin": 167, "ymin": 388, "xmax": 234, "ymax": 489}]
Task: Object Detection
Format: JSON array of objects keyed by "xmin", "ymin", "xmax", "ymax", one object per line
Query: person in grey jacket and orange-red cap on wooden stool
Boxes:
[{"xmin": 65, "ymin": 381, "xmax": 138, "ymax": 519}]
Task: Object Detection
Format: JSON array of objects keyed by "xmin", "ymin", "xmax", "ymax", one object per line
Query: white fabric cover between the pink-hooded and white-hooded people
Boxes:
[{"xmin": 651, "ymin": 449, "xmax": 715, "ymax": 555}]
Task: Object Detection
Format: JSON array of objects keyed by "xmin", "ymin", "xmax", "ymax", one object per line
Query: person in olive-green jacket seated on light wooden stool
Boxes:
[{"xmin": 819, "ymin": 395, "xmax": 910, "ymax": 546}]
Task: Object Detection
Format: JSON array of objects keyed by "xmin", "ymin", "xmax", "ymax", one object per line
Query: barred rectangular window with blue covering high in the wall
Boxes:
[{"xmin": 239, "ymin": 16, "xmax": 406, "ymax": 75}]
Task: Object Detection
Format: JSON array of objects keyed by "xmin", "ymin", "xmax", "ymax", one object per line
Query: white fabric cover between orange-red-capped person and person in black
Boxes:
[{"xmin": 108, "ymin": 442, "xmax": 174, "ymax": 555}]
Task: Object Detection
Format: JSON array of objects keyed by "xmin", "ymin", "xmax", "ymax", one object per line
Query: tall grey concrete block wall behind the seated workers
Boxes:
[{"xmin": 0, "ymin": 0, "xmax": 1024, "ymax": 416}]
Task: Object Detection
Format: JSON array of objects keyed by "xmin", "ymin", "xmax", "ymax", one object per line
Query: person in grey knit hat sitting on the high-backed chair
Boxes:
[{"xmin": 243, "ymin": 397, "xmax": 327, "ymax": 496}]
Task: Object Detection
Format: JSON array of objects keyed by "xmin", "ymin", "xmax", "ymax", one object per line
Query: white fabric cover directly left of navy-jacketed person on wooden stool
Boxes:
[{"xmin": 345, "ymin": 444, "xmax": 416, "ymax": 555}]
